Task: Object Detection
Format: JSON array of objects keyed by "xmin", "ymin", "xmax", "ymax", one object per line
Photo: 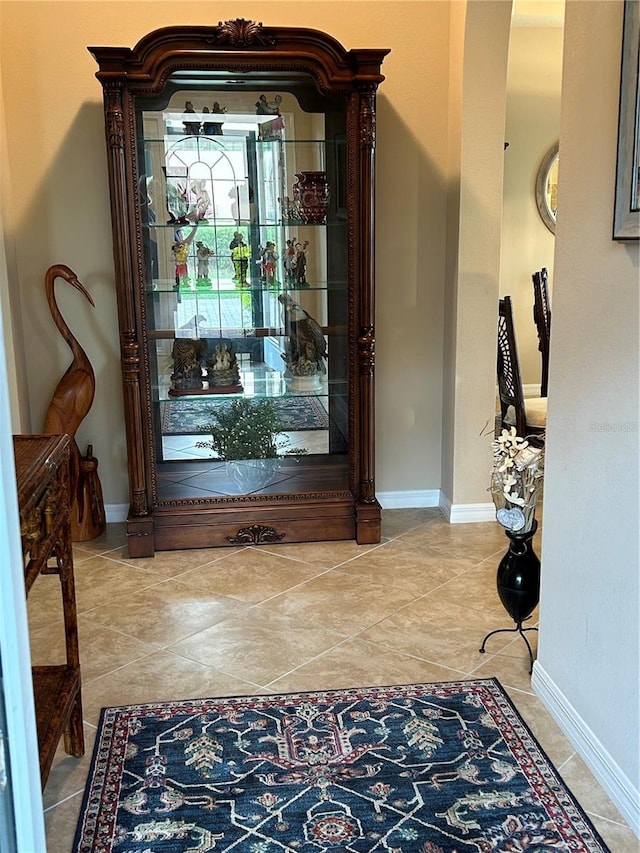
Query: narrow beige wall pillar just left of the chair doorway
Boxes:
[{"xmin": 442, "ymin": 0, "xmax": 511, "ymax": 506}]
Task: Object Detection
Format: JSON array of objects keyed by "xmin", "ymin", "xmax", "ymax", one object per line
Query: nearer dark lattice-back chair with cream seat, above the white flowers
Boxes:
[{"xmin": 497, "ymin": 296, "xmax": 547, "ymax": 437}]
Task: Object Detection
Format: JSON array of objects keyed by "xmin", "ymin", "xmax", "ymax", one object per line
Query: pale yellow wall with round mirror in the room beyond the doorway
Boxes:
[{"xmin": 500, "ymin": 16, "xmax": 563, "ymax": 386}]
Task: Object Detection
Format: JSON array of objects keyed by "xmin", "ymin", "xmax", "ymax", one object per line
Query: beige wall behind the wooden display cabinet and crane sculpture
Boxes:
[{"xmin": 0, "ymin": 0, "xmax": 449, "ymax": 504}]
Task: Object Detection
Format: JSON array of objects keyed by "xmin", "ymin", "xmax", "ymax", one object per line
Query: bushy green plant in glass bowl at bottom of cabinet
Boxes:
[{"xmin": 196, "ymin": 399, "xmax": 306, "ymax": 462}]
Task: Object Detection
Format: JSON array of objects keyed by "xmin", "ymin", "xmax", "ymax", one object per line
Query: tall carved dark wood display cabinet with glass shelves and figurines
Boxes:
[{"xmin": 89, "ymin": 18, "xmax": 388, "ymax": 557}]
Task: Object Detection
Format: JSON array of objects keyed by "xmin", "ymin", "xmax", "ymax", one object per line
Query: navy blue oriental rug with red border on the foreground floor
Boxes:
[{"xmin": 73, "ymin": 679, "xmax": 607, "ymax": 853}]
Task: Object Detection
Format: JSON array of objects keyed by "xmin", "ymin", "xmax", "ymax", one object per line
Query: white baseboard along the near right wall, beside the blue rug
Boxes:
[{"xmin": 531, "ymin": 661, "xmax": 640, "ymax": 838}]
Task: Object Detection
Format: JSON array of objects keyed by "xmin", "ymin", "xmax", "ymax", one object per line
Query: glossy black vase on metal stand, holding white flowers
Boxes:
[{"xmin": 496, "ymin": 520, "xmax": 540, "ymax": 625}]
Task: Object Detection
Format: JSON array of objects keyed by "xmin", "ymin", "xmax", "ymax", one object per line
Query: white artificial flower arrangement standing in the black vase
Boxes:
[{"xmin": 491, "ymin": 427, "xmax": 544, "ymax": 533}]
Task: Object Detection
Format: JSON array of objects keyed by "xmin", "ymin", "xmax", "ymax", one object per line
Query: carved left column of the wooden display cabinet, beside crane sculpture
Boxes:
[{"xmin": 104, "ymin": 83, "xmax": 154, "ymax": 557}]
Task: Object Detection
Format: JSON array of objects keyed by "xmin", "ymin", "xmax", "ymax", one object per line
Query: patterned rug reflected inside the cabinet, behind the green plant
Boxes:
[{"xmin": 160, "ymin": 397, "xmax": 329, "ymax": 435}]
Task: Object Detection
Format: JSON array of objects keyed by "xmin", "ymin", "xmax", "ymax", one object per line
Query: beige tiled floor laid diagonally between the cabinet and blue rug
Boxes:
[{"xmin": 29, "ymin": 509, "xmax": 640, "ymax": 853}]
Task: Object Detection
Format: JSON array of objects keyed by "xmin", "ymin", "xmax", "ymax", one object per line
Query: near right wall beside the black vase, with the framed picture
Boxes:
[{"xmin": 534, "ymin": 0, "xmax": 640, "ymax": 816}]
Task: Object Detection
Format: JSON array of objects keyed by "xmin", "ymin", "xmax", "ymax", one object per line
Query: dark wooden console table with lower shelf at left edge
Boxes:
[{"xmin": 13, "ymin": 435, "xmax": 84, "ymax": 787}]
